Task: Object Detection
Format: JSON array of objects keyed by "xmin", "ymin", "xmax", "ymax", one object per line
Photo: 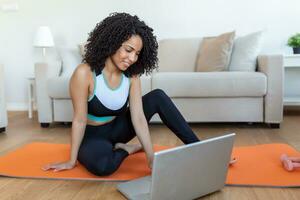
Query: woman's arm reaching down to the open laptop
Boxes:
[{"xmin": 129, "ymin": 76, "xmax": 153, "ymax": 168}]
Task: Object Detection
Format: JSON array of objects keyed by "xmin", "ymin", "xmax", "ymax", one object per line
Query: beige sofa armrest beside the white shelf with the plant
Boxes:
[{"xmin": 258, "ymin": 55, "xmax": 284, "ymax": 124}]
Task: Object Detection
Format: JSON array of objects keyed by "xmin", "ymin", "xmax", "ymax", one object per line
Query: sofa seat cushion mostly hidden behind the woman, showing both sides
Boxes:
[{"xmin": 47, "ymin": 75, "xmax": 151, "ymax": 99}]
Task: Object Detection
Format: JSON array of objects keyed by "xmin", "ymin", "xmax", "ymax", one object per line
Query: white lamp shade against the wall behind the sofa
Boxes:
[{"xmin": 33, "ymin": 26, "xmax": 54, "ymax": 47}]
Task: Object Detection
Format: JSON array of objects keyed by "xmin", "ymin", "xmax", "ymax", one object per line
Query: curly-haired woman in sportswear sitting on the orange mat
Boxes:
[{"xmin": 43, "ymin": 13, "xmax": 199, "ymax": 176}]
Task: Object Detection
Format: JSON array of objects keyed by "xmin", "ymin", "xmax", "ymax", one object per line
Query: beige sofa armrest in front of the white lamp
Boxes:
[{"xmin": 34, "ymin": 62, "xmax": 61, "ymax": 123}]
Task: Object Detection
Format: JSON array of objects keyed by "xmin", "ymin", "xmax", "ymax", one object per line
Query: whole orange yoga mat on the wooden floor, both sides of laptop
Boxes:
[{"xmin": 0, "ymin": 143, "xmax": 300, "ymax": 187}]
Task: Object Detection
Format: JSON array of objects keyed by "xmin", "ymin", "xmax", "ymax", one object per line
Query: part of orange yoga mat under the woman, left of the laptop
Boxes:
[{"xmin": 0, "ymin": 143, "xmax": 167, "ymax": 181}]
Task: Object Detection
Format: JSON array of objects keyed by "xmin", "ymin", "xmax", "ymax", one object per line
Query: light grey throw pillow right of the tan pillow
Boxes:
[{"xmin": 229, "ymin": 31, "xmax": 262, "ymax": 72}]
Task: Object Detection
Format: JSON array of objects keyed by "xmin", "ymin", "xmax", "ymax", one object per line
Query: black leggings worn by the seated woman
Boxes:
[{"xmin": 78, "ymin": 89, "xmax": 199, "ymax": 176}]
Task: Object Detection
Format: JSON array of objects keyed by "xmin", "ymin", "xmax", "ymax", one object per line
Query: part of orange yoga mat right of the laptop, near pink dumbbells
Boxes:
[{"xmin": 226, "ymin": 144, "xmax": 300, "ymax": 187}]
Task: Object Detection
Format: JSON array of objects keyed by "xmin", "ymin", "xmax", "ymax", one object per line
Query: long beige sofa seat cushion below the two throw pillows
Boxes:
[{"xmin": 152, "ymin": 72, "xmax": 267, "ymax": 97}]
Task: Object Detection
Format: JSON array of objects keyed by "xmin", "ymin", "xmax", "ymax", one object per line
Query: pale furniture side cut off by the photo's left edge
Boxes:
[{"xmin": 0, "ymin": 64, "xmax": 7, "ymax": 133}]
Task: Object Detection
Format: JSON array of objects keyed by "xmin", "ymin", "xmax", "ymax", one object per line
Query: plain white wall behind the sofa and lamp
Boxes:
[{"xmin": 0, "ymin": 0, "xmax": 300, "ymax": 110}]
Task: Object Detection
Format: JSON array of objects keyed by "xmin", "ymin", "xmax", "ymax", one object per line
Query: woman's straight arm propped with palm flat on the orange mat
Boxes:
[{"xmin": 43, "ymin": 64, "xmax": 90, "ymax": 171}]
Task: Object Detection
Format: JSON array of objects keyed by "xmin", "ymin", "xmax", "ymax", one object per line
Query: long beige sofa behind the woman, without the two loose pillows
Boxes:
[{"xmin": 35, "ymin": 38, "xmax": 283, "ymax": 128}]
